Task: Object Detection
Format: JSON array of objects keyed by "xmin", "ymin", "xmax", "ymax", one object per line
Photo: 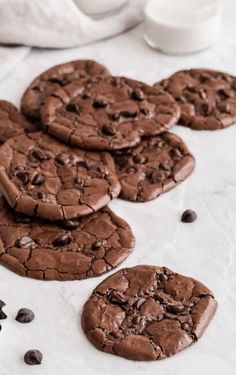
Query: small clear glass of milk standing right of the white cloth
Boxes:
[{"xmin": 144, "ymin": 0, "xmax": 221, "ymax": 54}]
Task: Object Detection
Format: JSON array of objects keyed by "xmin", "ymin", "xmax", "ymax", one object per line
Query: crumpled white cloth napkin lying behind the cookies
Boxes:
[{"xmin": 0, "ymin": 0, "xmax": 142, "ymax": 79}]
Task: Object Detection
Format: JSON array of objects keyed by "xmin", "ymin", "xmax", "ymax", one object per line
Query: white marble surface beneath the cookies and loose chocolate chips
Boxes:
[{"xmin": 0, "ymin": 0, "xmax": 236, "ymax": 375}]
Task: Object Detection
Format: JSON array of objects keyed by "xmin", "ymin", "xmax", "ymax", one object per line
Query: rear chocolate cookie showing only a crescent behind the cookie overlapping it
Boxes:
[{"xmin": 21, "ymin": 60, "xmax": 109, "ymax": 118}]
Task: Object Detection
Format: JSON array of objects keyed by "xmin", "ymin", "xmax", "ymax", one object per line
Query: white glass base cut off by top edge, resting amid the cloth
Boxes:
[{"xmin": 74, "ymin": 0, "xmax": 128, "ymax": 18}]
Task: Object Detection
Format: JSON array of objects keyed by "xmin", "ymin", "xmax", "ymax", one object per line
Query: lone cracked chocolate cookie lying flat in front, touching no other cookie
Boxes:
[{"xmin": 82, "ymin": 266, "xmax": 217, "ymax": 361}]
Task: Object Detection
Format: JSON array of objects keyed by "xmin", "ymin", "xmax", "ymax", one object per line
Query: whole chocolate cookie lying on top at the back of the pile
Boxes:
[{"xmin": 41, "ymin": 77, "xmax": 180, "ymax": 150}]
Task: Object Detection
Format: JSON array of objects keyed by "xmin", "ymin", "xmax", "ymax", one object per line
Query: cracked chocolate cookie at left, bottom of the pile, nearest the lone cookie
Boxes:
[{"xmin": 0, "ymin": 198, "xmax": 134, "ymax": 280}]
